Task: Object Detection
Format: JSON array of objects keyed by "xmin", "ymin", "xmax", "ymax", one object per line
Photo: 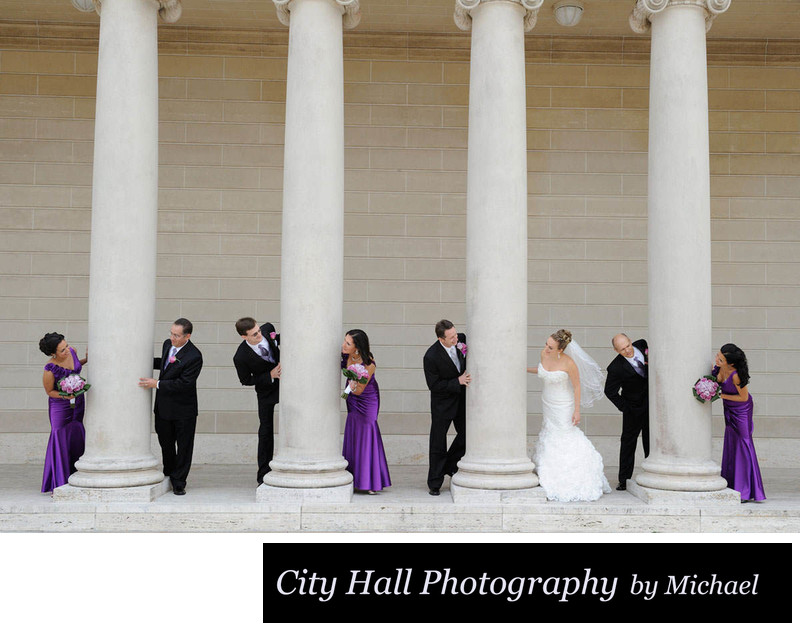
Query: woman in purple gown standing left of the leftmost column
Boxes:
[{"xmin": 39, "ymin": 333, "xmax": 88, "ymax": 493}]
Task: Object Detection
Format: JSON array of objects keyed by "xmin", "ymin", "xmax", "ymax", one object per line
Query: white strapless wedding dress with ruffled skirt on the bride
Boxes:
[{"xmin": 534, "ymin": 364, "xmax": 611, "ymax": 502}]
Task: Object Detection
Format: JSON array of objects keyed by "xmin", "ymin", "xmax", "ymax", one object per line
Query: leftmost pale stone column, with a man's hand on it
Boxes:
[{"xmin": 54, "ymin": 0, "xmax": 181, "ymax": 500}]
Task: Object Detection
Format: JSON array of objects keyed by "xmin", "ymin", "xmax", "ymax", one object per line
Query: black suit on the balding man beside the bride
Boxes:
[{"xmin": 605, "ymin": 340, "xmax": 650, "ymax": 482}]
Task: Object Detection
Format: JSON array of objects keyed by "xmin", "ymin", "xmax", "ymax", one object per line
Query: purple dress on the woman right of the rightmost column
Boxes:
[{"xmin": 713, "ymin": 367, "xmax": 767, "ymax": 501}]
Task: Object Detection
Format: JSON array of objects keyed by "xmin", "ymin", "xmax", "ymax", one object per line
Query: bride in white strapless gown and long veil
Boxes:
[{"xmin": 528, "ymin": 329, "xmax": 611, "ymax": 502}]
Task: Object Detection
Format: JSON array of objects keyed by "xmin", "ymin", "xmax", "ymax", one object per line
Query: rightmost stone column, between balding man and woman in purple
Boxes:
[{"xmin": 628, "ymin": 0, "xmax": 730, "ymax": 501}]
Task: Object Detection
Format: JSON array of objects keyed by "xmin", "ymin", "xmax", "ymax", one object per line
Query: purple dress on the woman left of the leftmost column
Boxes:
[{"xmin": 42, "ymin": 348, "xmax": 86, "ymax": 493}]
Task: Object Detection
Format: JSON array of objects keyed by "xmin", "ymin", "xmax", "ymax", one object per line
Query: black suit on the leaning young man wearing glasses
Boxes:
[{"xmin": 233, "ymin": 322, "xmax": 281, "ymax": 484}]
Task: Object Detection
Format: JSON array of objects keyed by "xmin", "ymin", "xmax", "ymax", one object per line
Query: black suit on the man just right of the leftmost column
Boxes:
[{"xmin": 153, "ymin": 340, "xmax": 203, "ymax": 490}]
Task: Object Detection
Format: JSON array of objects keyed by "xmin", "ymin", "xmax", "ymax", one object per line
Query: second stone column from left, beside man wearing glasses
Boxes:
[{"xmin": 257, "ymin": 0, "xmax": 360, "ymax": 502}]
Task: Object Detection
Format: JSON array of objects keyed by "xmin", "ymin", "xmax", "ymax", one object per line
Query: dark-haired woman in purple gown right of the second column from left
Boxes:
[{"xmin": 342, "ymin": 329, "xmax": 392, "ymax": 495}]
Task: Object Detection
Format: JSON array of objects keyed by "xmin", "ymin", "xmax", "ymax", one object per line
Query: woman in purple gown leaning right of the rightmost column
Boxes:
[{"xmin": 712, "ymin": 344, "xmax": 767, "ymax": 502}]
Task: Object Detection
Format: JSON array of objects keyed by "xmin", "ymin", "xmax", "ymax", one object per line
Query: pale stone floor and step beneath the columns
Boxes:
[{"xmin": 0, "ymin": 465, "xmax": 800, "ymax": 533}]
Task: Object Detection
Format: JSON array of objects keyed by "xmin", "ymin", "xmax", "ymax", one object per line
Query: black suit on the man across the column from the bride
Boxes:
[{"xmin": 422, "ymin": 333, "xmax": 467, "ymax": 489}]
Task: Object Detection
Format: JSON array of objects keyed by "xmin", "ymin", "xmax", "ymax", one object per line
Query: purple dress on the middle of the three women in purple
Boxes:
[{"xmin": 342, "ymin": 356, "xmax": 392, "ymax": 491}]
